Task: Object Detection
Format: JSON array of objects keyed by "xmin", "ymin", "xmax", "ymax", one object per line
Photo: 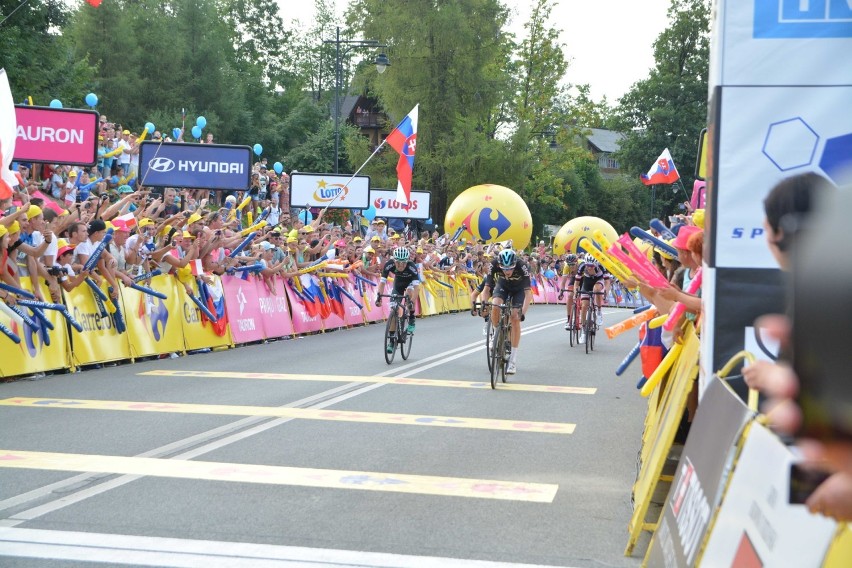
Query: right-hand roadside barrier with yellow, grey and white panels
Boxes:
[{"xmin": 625, "ymin": 323, "xmax": 852, "ymax": 568}]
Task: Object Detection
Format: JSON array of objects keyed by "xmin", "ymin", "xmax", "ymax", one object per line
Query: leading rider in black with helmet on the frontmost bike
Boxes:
[{"xmin": 490, "ymin": 248, "xmax": 532, "ymax": 375}]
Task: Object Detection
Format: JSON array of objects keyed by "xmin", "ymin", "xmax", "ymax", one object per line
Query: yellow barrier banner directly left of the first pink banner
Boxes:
[{"xmin": 180, "ymin": 276, "xmax": 234, "ymax": 351}]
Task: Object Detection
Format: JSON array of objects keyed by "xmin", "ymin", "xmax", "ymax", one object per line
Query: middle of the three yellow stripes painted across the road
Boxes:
[{"xmin": 0, "ymin": 397, "xmax": 576, "ymax": 434}]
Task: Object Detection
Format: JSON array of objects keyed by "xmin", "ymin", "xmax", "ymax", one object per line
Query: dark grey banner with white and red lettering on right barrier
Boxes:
[{"xmin": 646, "ymin": 379, "xmax": 751, "ymax": 568}]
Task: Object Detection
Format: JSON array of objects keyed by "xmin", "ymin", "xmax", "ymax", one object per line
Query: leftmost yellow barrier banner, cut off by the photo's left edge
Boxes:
[{"xmin": 0, "ymin": 278, "xmax": 69, "ymax": 377}]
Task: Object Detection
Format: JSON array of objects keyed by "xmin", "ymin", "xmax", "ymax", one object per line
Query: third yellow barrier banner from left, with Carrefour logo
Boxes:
[{"xmin": 121, "ymin": 274, "xmax": 185, "ymax": 358}]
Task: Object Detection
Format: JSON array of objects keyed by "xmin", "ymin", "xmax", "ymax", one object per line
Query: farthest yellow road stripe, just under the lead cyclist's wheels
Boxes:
[{"xmin": 138, "ymin": 369, "xmax": 598, "ymax": 394}]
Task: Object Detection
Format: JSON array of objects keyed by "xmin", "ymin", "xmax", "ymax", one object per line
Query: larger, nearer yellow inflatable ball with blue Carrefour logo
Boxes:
[{"xmin": 444, "ymin": 183, "xmax": 532, "ymax": 250}]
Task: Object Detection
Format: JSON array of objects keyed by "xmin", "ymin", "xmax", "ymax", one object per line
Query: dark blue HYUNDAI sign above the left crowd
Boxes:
[{"xmin": 138, "ymin": 142, "xmax": 251, "ymax": 191}]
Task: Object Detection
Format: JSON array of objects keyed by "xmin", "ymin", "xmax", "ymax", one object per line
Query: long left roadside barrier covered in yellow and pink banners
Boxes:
[{"xmin": 0, "ymin": 271, "xmax": 644, "ymax": 378}]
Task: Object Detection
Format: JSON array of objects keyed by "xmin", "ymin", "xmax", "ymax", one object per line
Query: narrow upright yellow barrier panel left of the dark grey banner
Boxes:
[{"xmin": 624, "ymin": 326, "xmax": 700, "ymax": 556}]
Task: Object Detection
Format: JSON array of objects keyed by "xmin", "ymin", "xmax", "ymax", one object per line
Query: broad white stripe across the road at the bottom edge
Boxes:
[{"xmin": 0, "ymin": 527, "xmax": 572, "ymax": 568}]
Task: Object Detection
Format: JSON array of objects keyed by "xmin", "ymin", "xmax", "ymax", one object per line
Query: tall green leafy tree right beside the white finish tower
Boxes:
[{"xmin": 616, "ymin": 0, "xmax": 710, "ymax": 216}]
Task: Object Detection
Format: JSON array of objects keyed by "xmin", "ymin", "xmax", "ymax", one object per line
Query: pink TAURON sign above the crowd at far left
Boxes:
[{"xmin": 14, "ymin": 105, "xmax": 99, "ymax": 166}]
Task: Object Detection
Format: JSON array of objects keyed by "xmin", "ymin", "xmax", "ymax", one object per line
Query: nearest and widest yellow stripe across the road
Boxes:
[{"xmin": 0, "ymin": 449, "xmax": 559, "ymax": 503}]
